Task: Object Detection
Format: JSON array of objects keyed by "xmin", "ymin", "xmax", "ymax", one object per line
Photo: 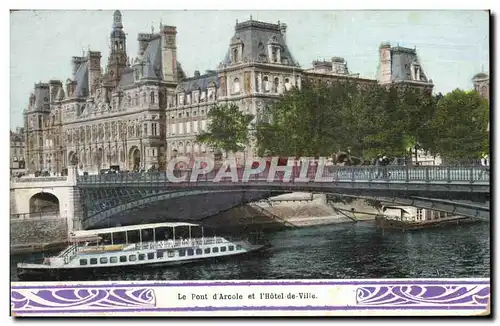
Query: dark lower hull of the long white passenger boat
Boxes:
[{"xmin": 17, "ymin": 244, "xmax": 270, "ymax": 281}]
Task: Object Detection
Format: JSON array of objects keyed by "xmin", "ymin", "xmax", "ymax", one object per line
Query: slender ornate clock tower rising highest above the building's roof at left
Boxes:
[{"xmin": 107, "ymin": 10, "xmax": 128, "ymax": 87}]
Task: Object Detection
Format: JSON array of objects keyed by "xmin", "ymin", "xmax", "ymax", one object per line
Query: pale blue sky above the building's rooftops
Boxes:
[{"xmin": 10, "ymin": 10, "xmax": 489, "ymax": 128}]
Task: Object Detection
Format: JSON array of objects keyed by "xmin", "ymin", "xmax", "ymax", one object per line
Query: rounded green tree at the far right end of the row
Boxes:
[{"xmin": 431, "ymin": 89, "xmax": 489, "ymax": 161}]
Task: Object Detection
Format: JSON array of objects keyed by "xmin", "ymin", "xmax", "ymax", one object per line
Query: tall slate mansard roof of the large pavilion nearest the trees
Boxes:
[{"xmin": 223, "ymin": 20, "xmax": 297, "ymax": 65}]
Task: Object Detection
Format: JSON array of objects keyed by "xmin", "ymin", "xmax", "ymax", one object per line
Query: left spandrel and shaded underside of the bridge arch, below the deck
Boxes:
[{"xmin": 81, "ymin": 188, "xmax": 282, "ymax": 229}]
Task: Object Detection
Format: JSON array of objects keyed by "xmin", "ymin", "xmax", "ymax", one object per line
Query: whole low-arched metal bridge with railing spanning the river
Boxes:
[{"xmin": 76, "ymin": 166, "xmax": 490, "ymax": 229}]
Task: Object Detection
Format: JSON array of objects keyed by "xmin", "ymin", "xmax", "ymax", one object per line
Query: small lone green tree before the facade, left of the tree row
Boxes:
[{"xmin": 196, "ymin": 103, "xmax": 253, "ymax": 156}]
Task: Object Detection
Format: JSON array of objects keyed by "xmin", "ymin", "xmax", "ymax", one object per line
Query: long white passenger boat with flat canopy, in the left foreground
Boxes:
[{"xmin": 17, "ymin": 223, "xmax": 268, "ymax": 280}]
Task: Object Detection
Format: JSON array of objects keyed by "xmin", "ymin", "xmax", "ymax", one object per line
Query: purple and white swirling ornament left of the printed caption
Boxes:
[{"xmin": 11, "ymin": 288, "xmax": 156, "ymax": 311}]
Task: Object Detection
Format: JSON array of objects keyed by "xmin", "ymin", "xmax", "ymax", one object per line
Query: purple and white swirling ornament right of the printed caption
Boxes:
[{"xmin": 356, "ymin": 284, "xmax": 491, "ymax": 308}]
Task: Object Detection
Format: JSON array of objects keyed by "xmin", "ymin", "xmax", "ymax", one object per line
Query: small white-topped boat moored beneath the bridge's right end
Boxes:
[{"xmin": 375, "ymin": 206, "xmax": 472, "ymax": 231}]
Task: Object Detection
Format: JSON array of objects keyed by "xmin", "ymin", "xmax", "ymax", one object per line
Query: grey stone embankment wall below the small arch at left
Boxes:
[{"xmin": 10, "ymin": 218, "xmax": 68, "ymax": 253}]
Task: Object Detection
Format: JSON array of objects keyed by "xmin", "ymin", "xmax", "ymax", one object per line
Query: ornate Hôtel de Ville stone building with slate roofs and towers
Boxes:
[{"xmin": 25, "ymin": 11, "xmax": 432, "ymax": 173}]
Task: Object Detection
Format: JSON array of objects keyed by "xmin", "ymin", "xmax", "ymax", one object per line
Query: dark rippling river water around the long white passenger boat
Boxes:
[{"xmin": 11, "ymin": 222, "xmax": 490, "ymax": 281}]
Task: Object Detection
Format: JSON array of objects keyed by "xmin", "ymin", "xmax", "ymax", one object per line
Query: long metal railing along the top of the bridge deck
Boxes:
[{"xmin": 78, "ymin": 166, "xmax": 490, "ymax": 184}]
